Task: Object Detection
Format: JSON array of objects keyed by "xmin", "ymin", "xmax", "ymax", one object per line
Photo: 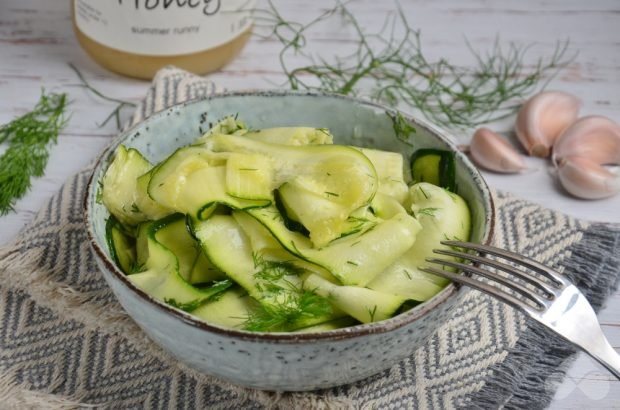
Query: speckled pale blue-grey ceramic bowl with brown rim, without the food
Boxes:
[{"xmin": 85, "ymin": 91, "xmax": 494, "ymax": 391}]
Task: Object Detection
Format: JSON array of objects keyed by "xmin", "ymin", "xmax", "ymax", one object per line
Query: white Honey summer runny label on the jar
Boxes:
[{"xmin": 73, "ymin": 0, "xmax": 255, "ymax": 56}]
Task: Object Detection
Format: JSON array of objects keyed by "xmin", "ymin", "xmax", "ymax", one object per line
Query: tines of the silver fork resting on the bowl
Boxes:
[{"xmin": 421, "ymin": 241, "xmax": 566, "ymax": 311}]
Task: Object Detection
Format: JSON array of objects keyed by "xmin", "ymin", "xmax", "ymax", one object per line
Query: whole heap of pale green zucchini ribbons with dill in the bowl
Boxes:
[{"xmin": 103, "ymin": 116, "xmax": 471, "ymax": 332}]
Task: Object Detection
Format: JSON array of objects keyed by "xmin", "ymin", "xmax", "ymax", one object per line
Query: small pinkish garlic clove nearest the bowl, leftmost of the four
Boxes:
[{"xmin": 469, "ymin": 127, "xmax": 526, "ymax": 174}]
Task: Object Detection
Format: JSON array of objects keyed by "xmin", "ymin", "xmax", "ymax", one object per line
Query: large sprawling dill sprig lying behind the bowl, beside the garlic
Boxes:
[{"xmin": 255, "ymin": 0, "xmax": 574, "ymax": 129}]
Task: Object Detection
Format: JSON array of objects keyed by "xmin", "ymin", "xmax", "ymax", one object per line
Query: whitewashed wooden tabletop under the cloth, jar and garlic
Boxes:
[{"xmin": 0, "ymin": 0, "xmax": 620, "ymax": 409}]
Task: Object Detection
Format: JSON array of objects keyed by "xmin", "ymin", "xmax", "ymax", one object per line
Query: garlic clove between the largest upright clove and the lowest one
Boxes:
[{"xmin": 552, "ymin": 115, "xmax": 620, "ymax": 164}]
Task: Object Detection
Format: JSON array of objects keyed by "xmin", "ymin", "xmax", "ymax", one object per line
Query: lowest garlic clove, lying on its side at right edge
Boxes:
[{"xmin": 558, "ymin": 156, "xmax": 620, "ymax": 199}]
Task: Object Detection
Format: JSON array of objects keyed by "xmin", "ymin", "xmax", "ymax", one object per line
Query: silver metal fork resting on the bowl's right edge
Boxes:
[{"xmin": 421, "ymin": 241, "xmax": 620, "ymax": 379}]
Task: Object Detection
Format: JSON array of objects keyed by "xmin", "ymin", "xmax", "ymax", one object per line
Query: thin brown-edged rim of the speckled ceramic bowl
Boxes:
[{"xmin": 83, "ymin": 90, "xmax": 496, "ymax": 343}]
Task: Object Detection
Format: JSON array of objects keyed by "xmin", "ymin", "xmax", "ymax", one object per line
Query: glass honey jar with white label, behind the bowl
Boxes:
[{"xmin": 71, "ymin": 0, "xmax": 255, "ymax": 79}]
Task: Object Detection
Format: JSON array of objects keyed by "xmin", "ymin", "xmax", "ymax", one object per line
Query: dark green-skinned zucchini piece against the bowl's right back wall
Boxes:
[{"xmin": 411, "ymin": 148, "xmax": 456, "ymax": 192}]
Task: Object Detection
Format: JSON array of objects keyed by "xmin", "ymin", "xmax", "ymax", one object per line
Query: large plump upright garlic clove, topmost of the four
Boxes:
[{"xmin": 515, "ymin": 91, "xmax": 581, "ymax": 158}]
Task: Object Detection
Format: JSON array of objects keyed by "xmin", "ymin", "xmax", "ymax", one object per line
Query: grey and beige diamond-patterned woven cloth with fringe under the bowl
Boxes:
[{"xmin": 0, "ymin": 68, "xmax": 620, "ymax": 409}]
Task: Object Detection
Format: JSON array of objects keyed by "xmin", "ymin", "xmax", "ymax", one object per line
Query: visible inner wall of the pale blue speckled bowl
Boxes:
[{"xmin": 86, "ymin": 91, "xmax": 494, "ymax": 332}]
